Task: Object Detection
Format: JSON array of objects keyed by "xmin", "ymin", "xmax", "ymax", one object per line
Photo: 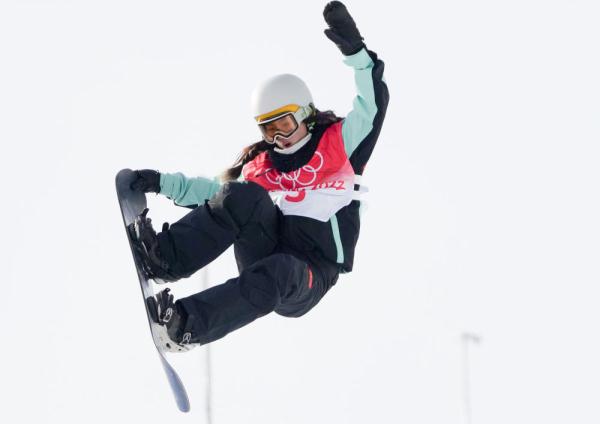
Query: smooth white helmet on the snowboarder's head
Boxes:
[{"xmin": 251, "ymin": 74, "xmax": 314, "ymax": 142}]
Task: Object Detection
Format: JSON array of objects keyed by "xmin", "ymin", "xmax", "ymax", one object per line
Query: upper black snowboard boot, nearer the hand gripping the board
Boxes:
[{"xmin": 127, "ymin": 208, "xmax": 178, "ymax": 284}]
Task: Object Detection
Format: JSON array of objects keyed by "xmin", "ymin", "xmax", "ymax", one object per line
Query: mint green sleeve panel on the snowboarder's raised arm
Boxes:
[{"xmin": 342, "ymin": 48, "xmax": 377, "ymax": 156}]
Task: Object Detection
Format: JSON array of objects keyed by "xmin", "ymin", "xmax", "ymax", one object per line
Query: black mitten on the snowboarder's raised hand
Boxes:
[{"xmin": 323, "ymin": 1, "xmax": 365, "ymax": 56}]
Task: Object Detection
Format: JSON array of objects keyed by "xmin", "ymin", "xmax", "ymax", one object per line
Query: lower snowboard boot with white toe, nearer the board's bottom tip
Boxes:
[{"xmin": 146, "ymin": 289, "xmax": 196, "ymax": 352}]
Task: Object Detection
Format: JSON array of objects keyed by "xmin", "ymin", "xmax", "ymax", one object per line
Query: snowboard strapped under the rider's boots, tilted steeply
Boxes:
[{"xmin": 116, "ymin": 169, "xmax": 190, "ymax": 412}]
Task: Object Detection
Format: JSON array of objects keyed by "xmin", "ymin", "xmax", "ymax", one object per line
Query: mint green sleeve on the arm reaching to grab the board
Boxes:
[{"xmin": 160, "ymin": 172, "xmax": 221, "ymax": 206}]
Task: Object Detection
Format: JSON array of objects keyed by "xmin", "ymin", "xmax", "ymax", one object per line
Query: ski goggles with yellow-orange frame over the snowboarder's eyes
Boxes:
[{"xmin": 256, "ymin": 105, "xmax": 312, "ymax": 144}]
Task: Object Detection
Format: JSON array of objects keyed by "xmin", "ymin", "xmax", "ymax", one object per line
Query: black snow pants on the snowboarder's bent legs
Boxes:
[{"xmin": 158, "ymin": 182, "xmax": 339, "ymax": 344}]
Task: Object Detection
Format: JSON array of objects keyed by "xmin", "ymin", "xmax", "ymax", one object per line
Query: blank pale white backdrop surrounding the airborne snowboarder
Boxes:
[{"xmin": 0, "ymin": 0, "xmax": 600, "ymax": 424}]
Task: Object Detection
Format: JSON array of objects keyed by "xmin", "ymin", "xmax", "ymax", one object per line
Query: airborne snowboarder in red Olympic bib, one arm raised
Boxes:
[{"xmin": 129, "ymin": 1, "xmax": 389, "ymax": 351}]
